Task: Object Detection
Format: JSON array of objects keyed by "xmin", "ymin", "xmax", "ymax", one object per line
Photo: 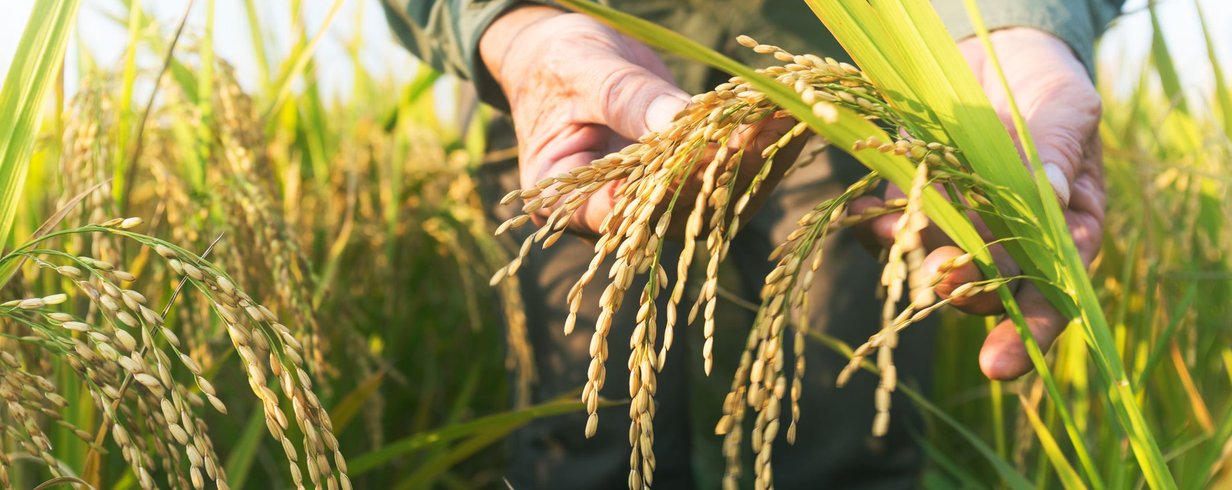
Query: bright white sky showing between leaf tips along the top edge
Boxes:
[{"xmin": 0, "ymin": 0, "xmax": 1232, "ymax": 106}]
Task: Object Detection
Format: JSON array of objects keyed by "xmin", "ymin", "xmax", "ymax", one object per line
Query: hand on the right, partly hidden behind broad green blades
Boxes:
[{"xmin": 851, "ymin": 27, "xmax": 1106, "ymax": 379}]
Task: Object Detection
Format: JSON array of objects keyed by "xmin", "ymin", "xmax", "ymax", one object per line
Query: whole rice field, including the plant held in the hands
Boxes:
[{"xmin": 0, "ymin": 0, "xmax": 1232, "ymax": 489}]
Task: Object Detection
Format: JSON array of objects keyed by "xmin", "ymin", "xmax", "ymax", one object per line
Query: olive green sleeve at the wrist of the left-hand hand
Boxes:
[{"xmin": 381, "ymin": 0, "xmax": 519, "ymax": 110}]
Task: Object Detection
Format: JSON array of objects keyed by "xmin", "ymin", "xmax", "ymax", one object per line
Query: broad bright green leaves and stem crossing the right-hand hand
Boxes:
[{"xmin": 808, "ymin": 1, "xmax": 1170, "ymax": 488}]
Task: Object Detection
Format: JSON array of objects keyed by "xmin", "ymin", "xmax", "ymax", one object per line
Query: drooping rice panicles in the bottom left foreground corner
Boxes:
[{"xmin": 0, "ymin": 218, "xmax": 350, "ymax": 489}]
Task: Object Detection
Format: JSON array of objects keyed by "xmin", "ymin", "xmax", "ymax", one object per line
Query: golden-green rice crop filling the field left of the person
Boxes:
[{"xmin": 0, "ymin": 2, "xmax": 539, "ymax": 488}]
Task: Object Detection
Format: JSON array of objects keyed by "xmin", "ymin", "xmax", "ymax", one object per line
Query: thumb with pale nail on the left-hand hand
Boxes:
[{"xmin": 588, "ymin": 58, "xmax": 689, "ymax": 140}]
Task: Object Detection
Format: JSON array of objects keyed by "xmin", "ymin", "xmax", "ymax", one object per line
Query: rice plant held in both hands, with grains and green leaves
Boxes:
[{"xmin": 494, "ymin": 1, "xmax": 1232, "ymax": 488}]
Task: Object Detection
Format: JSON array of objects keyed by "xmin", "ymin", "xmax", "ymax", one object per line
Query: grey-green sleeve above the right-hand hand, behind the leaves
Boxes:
[{"xmin": 933, "ymin": 0, "xmax": 1125, "ymax": 74}]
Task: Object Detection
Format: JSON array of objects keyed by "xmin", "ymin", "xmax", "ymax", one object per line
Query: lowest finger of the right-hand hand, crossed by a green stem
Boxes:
[{"xmin": 979, "ymin": 284, "xmax": 1069, "ymax": 380}]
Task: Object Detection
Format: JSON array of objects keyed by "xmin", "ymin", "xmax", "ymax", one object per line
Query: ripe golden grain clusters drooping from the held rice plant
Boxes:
[{"xmin": 493, "ymin": 36, "xmax": 1003, "ymax": 489}]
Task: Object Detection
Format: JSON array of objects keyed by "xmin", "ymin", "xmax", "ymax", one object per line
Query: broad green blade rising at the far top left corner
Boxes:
[{"xmin": 0, "ymin": 0, "xmax": 79, "ymax": 246}]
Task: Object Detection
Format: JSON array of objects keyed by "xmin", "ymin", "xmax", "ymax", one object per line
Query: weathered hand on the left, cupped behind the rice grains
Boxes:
[{"xmin": 479, "ymin": 5, "xmax": 803, "ymax": 235}]
